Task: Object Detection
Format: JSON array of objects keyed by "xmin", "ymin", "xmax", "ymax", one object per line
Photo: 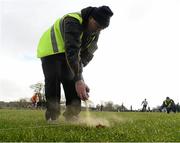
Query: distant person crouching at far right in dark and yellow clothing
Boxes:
[{"xmin": 161, "ymin": 97, "xmax": 176, "ymax": 114}]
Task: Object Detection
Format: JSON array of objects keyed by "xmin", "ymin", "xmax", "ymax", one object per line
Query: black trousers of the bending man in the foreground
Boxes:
[{"xmin": 41, "ymin": 53, "xmax": 81, "ymax": 118}]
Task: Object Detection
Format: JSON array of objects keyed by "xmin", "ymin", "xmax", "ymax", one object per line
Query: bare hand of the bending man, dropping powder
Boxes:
[{"xmin": 75, "ymin": 80, "xmax": 89, "ymax": 101}]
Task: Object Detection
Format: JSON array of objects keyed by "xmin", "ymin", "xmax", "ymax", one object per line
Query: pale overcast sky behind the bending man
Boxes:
[{"xmin": 0, "ymin": 0, "xmax": 180, "ymax": 109}]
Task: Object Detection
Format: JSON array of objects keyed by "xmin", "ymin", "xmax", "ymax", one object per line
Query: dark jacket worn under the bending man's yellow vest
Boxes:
[{"xmin": 63, "ymin": 7, "xmax": 99, "ymax": 81}]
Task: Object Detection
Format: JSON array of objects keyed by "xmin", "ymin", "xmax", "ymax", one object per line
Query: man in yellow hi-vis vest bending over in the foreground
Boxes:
[{"xmin": 37, "ymin": 6, "xmax": 113, "ymax": 121}]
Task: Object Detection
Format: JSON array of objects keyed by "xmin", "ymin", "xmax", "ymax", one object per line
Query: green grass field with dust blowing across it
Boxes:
[{"xmin": 0, "ymin": 109, "xmax": 180, "ymax": 142}]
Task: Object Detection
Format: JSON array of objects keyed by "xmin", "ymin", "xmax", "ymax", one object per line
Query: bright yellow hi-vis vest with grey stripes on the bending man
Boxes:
[{"xmin": 37, "ymin": 13, "xmax": 83, "ymax": 58}]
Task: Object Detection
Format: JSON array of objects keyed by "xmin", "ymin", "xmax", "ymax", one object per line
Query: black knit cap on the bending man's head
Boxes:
[{"xmin": 91, "ymin": 6, "xmax": 113, "ymax": 28}]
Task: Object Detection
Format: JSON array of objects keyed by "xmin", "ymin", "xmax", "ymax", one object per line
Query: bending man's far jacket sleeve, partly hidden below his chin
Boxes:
[{"xmin": 81, "ymin": 33, "xmax": 100, "ymax": 67}]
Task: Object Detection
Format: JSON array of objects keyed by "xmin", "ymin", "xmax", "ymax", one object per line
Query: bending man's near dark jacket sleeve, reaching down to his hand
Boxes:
[{"xmin": 63, "ymin": 17, "xmax": 83, "ymax": 81}]
